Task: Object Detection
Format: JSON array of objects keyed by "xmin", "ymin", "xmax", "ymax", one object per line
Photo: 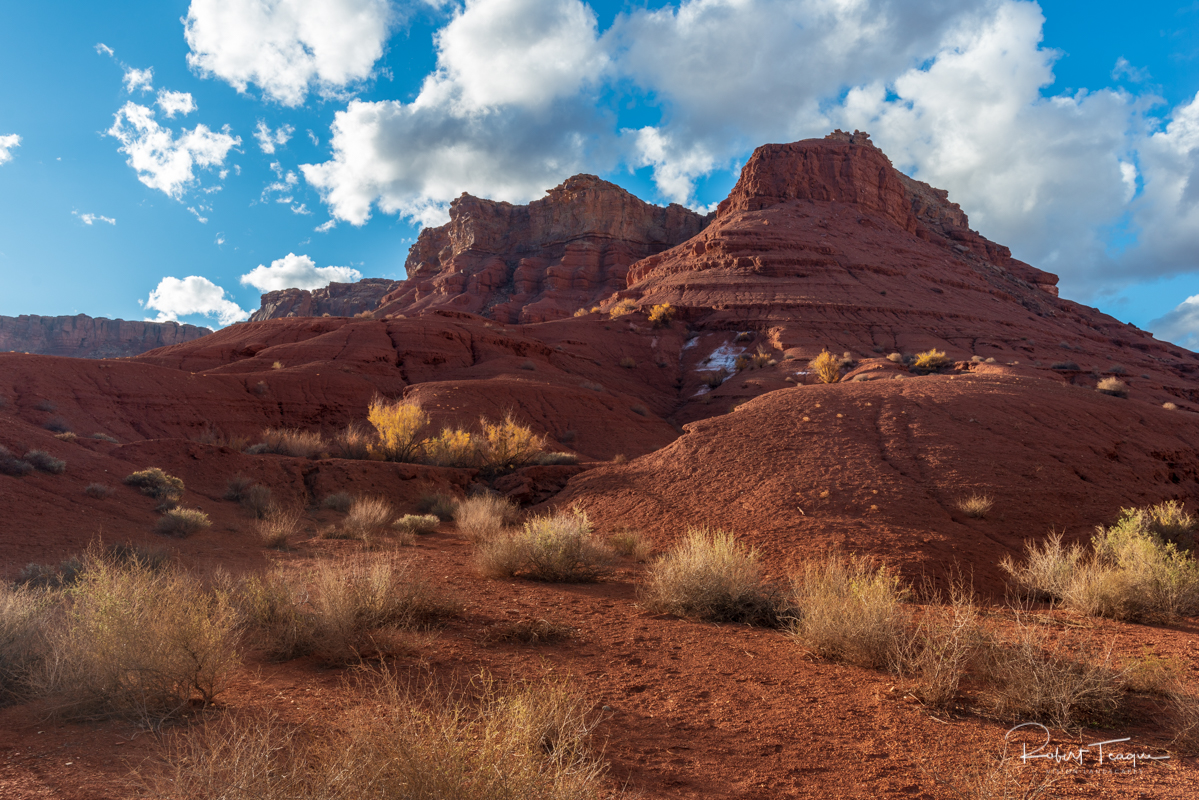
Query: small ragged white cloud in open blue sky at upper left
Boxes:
[{"xmin": 108, "ymin": 102, "xmax": 241, "ymax": 199}]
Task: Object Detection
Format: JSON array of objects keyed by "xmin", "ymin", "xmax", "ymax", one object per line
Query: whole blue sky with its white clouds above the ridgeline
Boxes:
[{"xmin": 0, "ymin": 0, "xmax": 1199, "ymax": 347}]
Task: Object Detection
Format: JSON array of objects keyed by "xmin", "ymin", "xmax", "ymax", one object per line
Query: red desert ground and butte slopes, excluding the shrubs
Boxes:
[{"xmin": 0, "ymin": 133, "xmax": 1199, "ymax": 800}]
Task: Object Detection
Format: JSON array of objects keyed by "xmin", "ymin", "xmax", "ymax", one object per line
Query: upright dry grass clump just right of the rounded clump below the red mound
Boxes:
[{"xmin": 793, "ymin": 554, "xmax": 908, "ymax": 667}]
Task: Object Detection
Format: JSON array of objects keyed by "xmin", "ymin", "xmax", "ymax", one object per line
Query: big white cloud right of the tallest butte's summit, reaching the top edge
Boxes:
[{"xmin": 832, "ymin": 2, "xmax": 1138, "ymax": 296}]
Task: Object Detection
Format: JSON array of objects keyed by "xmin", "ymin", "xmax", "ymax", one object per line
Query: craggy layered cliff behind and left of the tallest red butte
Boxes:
[{"xmin": 378, "ymin": 175, "xmax": 711, "ymax": 323}]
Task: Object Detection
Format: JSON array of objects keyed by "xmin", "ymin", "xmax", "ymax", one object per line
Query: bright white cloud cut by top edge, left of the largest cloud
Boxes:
[{"xmin": 183, "ymin": 0, "xmax": 396, "ymax": 106}]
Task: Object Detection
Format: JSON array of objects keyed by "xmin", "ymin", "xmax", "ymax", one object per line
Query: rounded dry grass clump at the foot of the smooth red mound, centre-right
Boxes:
[{"xmin": 640, "ymin": 528, "xmax": 793, "ymax": 627}]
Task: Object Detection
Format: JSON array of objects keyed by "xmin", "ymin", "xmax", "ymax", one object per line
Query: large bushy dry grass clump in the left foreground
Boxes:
[{"xmin": 35, "ymin": 548, "xmax": 240, "ymax": 720}]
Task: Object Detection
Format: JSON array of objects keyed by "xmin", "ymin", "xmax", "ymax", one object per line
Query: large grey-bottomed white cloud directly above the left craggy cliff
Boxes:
[{"xmin": 301, "ymin": 0, "xmax": 614, "ymax": 225}]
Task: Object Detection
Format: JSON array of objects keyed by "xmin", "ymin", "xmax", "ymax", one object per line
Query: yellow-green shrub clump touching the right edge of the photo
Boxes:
[{"xmin": 1000, "ymin": 504, "xmax": 1199, "ymax": 621}]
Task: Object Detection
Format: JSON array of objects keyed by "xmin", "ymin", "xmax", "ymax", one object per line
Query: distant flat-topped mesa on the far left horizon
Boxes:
[{"xmin": 0, "ymin": 314, "xmax": 212, "ymax": 359}]
